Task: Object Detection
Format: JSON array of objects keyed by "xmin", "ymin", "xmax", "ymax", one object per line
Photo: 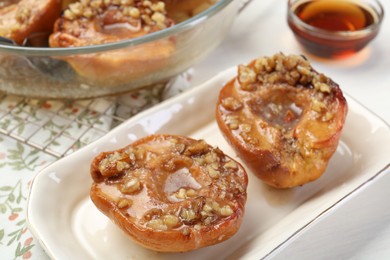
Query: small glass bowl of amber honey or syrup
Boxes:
[{"xmin": 287, "ymin": 0, "xmax": 384, "ymax": 58}]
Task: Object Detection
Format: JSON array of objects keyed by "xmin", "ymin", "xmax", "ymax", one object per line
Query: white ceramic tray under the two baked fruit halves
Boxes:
[{"xmin": 28, "ymin": 68, "xmax": 390, "ymax": 259}]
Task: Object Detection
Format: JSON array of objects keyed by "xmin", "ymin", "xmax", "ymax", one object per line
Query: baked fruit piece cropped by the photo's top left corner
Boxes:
[{"xmin": 0, "ymin": 0, "xmax": 61, "ymax": 44}]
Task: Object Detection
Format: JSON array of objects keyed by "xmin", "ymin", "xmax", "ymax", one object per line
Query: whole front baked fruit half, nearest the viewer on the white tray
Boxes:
[{"xmin": 90, "ymin": 134, "xmax": 248, "ymax": 252}]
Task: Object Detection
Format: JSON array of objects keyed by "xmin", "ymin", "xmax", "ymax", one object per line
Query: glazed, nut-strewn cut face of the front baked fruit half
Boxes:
[{"xmin": 97, "ymin": 138, "xmax": 245, "ymax": 232}]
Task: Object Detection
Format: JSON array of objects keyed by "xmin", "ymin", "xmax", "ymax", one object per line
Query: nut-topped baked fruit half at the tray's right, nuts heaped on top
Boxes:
[{"xmin": 216, "ymin": 53, "xmax": 348, "ymax": 188}]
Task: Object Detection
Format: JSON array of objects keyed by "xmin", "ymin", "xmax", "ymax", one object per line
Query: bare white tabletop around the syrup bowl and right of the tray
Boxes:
[{"xmin": 193, "ymin": 0, "xmax": 390, "ymax": 259}]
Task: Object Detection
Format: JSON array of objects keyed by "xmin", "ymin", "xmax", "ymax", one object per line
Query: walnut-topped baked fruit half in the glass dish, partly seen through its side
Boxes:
[{"xmin": 49, "ymin": 0, "xmax": 175, "ymax": 86}]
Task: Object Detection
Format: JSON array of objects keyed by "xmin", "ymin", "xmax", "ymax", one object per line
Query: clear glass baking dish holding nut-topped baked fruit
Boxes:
[{"xmin": 0, "ymin": 0, "xmax": 238, "ymax": 99}]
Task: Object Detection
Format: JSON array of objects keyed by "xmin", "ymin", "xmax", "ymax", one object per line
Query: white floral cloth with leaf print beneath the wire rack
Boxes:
[{"xmin": 0, "ymin": 73, "xmax": 190, "ymax": 259}]
